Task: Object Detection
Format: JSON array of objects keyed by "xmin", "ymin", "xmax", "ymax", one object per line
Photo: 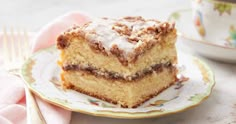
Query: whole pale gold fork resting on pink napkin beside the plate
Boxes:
[{"xmin": 2, "ymin": 28, "xmax": 45, "ymax": 124}]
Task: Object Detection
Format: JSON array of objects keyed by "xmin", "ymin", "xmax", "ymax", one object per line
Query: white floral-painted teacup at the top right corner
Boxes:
[{"xmin": 192, "ymin": 0, "xmax": 236, "ymax": 47}]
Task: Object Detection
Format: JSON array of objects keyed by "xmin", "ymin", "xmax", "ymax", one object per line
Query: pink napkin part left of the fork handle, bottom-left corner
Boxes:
[{"xmin": 0, "ymin": 73, "xmax": 26, "ymax": 124}]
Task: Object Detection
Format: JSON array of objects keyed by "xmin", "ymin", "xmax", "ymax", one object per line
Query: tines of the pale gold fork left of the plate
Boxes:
[{"xmin": 2, "ymin": 27, "xmax": 30, "ymax": 69}]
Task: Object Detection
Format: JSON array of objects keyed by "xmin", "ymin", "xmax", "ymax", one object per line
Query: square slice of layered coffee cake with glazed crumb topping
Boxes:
[{"xmin": 57, "ymin": 17, "xmax": 177, "ymax": 108}]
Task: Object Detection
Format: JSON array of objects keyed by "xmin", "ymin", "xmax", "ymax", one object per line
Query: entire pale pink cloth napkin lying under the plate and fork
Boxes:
[{"xmin": 0, "ymin": 12, "xmax": 90, "ymax": 124}]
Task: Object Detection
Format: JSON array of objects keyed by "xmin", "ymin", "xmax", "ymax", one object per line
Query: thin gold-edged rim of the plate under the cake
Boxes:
[{"xmin": 21, "ymin": 46, "xmax": 215, "ymax": 119}]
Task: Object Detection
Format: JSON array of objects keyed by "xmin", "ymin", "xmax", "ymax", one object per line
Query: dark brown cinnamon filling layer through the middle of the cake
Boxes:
[{"xmin": 62, "ymin": 63, "xmax": 176, "ymax": 81}]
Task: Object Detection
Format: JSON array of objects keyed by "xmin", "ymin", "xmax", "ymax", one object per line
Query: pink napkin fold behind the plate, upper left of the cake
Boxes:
[{"xmin": 32, "ymin": 12, "xmax": 90, "ymax": 51}]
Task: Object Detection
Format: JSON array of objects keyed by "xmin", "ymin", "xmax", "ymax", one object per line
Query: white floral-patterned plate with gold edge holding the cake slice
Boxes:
[{"xmin": 22, "ymin": 46, "xmax": 215, "ymax": 118}]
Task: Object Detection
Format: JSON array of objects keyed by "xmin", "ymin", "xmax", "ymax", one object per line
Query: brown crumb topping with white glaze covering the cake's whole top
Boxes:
[{"xmin": 58, "ymin": 16, "xmax": 175, "ymax": 64}]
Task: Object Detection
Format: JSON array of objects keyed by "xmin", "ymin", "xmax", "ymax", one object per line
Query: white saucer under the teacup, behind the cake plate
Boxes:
[{"xmin": 169, "ymin": 9, "xmax": 236, "ymax": 63}]
